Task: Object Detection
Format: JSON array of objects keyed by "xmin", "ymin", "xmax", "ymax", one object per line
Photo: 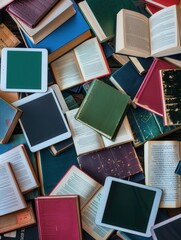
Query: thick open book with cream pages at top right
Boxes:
[{"xmin": 116, "ymin": 5, "xmax": 181, "ymax": 58}]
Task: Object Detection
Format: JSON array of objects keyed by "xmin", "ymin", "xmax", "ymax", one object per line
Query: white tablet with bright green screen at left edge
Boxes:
[{"xmin": 1, "ymin": 48, "xmax": 48, "ymax": 92}]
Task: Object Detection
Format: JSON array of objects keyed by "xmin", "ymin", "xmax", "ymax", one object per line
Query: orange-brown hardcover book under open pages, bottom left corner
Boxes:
[{"xmin": 0, "ymin": 202, "xmax": 36, "ymax": 234}]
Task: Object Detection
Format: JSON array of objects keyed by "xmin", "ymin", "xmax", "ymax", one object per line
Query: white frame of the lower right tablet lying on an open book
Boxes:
[{"xmin": 96, "ymin": 176, "xmax": 162, "ymax": 237}]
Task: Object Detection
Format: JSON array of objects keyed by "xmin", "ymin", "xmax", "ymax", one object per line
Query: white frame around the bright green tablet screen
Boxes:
[{"xmin": 1, "ymin": 48, "xmax": 48, "ymax": 93}]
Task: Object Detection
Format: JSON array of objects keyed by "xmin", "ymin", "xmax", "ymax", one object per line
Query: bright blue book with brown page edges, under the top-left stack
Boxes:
[{"xmin": 20, "ymin": 2, "xmax": 91, "ymax": 62}]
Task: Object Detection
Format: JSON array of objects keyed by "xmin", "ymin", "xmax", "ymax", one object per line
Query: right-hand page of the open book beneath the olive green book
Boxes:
[{"xmin": 102, "ymin": 117, "xmax": 134, "ymax": 147}]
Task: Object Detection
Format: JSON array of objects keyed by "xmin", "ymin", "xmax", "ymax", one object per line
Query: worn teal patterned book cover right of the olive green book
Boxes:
[{"xmin": 127, "ymin": 106, "xmax": 180, "ymax": 147}]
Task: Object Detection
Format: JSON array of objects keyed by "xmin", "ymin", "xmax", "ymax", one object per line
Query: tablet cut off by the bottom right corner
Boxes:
[{"xmin": 151, "ymin": 214, "xmax": 181, "ymax": 240}]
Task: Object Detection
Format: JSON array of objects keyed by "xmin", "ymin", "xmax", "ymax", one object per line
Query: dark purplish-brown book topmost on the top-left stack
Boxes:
[{"xmin": 6, "ymin": 0, "xmax": 59, "ymax": 28}]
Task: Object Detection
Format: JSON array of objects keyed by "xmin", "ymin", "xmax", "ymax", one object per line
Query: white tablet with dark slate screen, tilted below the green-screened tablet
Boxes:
[{"xmin": 13, "ymin": 87, "xmax": 71, "ymax": 152}]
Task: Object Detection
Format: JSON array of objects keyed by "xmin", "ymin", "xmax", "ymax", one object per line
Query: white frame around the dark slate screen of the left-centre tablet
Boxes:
[{"xmin": 13, "ymin": 87, "xmax": 71, "ymax": 152}]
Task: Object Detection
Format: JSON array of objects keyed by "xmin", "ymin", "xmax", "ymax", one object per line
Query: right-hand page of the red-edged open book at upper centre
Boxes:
[{"xmin": 74, "ymin": 38, "xmax": 109, "ymax": 81}]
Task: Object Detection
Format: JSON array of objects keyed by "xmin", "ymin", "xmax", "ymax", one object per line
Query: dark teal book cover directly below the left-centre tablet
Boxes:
[{"xmin": 37, "ymin": 146, "xmax": 78, "ymax": 195}]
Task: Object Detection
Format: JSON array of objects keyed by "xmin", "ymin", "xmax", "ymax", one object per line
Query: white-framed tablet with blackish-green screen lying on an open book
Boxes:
[{"xmin": 96, "ymin": 177, "xmax": 162, "ymax": 237}]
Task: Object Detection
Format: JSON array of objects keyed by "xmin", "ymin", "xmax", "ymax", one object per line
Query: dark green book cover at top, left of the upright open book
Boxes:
[{"xmin": 80, "ymin": 0, "xmax": 138, "ymax": 38}]
